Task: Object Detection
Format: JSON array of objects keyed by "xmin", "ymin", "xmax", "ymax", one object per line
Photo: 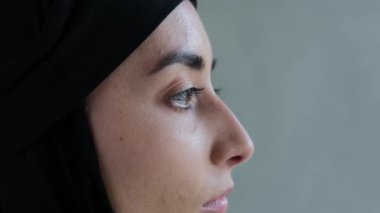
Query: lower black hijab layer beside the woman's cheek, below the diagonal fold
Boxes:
[{"xmin": 0, "ymin": 106, "xmax": 112, "ymax": 213}]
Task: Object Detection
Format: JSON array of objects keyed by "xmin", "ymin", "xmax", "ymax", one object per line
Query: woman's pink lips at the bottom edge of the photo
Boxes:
[{"xmin": 202, "ymin": 186, "xmax": 233, "ymax": 213}]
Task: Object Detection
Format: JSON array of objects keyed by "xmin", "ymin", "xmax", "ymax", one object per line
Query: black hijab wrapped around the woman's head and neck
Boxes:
[{"xmin": 0, "ymin": 0, "xmax": 194, "ymax": 213}]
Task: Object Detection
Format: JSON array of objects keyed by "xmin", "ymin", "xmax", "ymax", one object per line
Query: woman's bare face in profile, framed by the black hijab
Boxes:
[{"xmin": 88, "ymin": 1, "xmax": 253, "ymax": 213}]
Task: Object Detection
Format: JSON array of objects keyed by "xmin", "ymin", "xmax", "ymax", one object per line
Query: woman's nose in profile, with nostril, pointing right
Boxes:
[{"xmin": 210, "ymin": 97, "xmax": 254, "ymax": 168}]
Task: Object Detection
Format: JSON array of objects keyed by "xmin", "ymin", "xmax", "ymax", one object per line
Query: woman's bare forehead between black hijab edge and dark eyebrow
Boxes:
[{"xmin": 136, "ymin": 1, "xmax": 212, "ymax": 68}]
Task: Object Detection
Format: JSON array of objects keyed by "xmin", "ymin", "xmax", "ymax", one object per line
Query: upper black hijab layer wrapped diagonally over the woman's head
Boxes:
[{"xmin": 0, "ymin": 0, "xmax": 184, "ymax": 163}]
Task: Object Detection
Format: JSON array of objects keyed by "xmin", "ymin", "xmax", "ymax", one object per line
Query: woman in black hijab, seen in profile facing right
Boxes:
[{"xmin": 0, "ymin": 0, "xmax": 253, "ymax": 213}]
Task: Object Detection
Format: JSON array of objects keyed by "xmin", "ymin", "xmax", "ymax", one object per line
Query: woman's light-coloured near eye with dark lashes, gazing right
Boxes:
[{"xmin": 169, "ymin": 87, "xmax": 204, "ymax": 110}]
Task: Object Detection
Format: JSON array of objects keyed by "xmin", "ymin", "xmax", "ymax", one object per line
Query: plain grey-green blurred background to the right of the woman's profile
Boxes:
[{"xmin": 199, "ymin": 0, "xmax": 380, "ymax": 213}]
